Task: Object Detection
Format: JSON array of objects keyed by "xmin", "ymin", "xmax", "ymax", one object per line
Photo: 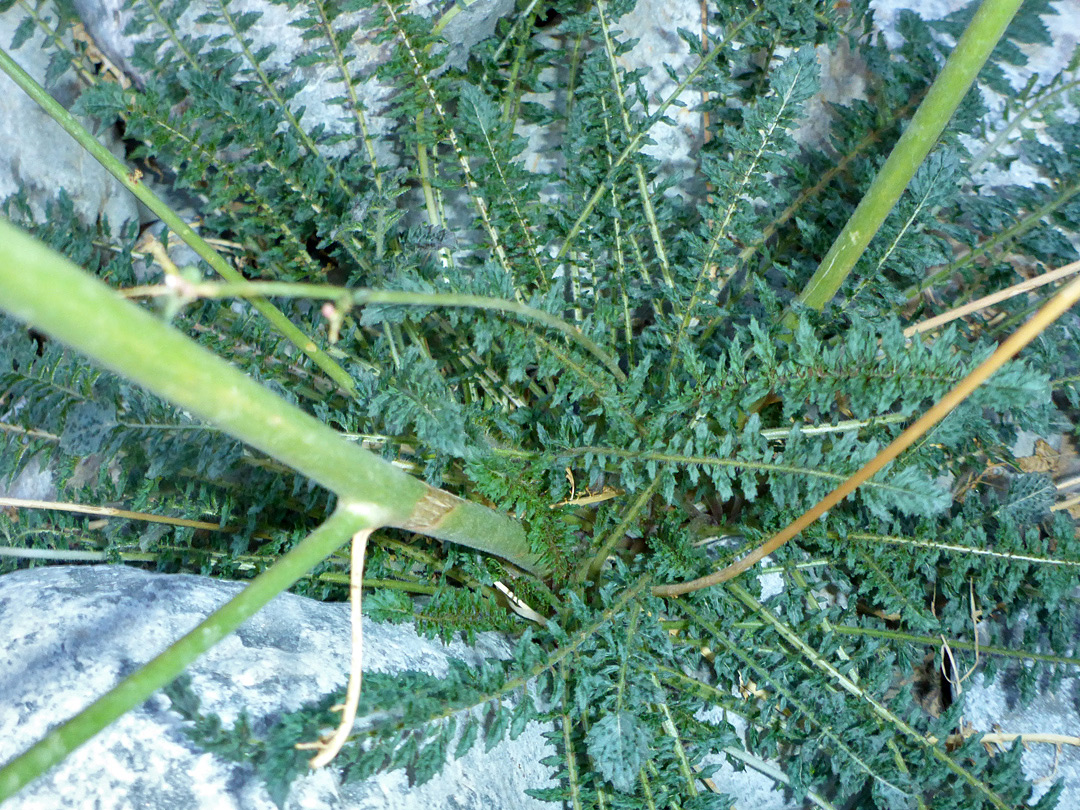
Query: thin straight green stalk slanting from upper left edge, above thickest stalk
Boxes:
[{"xmin": 0, "ymin": 48, "xmax": 356, "ymax": 396}]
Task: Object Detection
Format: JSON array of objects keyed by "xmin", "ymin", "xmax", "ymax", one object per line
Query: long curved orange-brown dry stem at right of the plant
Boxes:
[{"xmin": 652, "ymin": 268, "xmax": 1080, "ymax": 596}]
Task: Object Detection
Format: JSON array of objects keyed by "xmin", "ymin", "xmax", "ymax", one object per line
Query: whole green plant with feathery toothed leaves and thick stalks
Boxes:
[{"xmin": 0, "ymin": 0, "xmax": 1080, "ymax": 809}]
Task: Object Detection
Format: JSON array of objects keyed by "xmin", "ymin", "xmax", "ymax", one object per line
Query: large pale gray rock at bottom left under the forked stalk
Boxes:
[{"xmin": 0, "ymin": 566, "xmax": 555, "ymax": 810}]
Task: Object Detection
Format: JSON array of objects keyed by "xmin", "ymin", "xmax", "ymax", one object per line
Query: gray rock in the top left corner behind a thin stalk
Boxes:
[{"xmin": 0, "ymin": 2, "xmax": 138, "ymax": 231}]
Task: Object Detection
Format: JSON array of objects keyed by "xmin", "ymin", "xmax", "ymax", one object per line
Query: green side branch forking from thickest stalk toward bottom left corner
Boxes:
[{"xmin": 0, "ymin": 503, "xmax": 372, "ymax": 801}]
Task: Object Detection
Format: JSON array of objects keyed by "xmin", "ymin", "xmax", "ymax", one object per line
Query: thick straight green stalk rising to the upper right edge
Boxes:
[{"xmin": 785, "ymin": 0, "xmax": 1022, "ymax": 319}]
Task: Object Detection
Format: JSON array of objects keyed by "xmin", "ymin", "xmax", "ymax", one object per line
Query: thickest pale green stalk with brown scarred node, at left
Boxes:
[{"xmin": 0, "ymin": 220, "xmax": 546, "ymax": 575}]
